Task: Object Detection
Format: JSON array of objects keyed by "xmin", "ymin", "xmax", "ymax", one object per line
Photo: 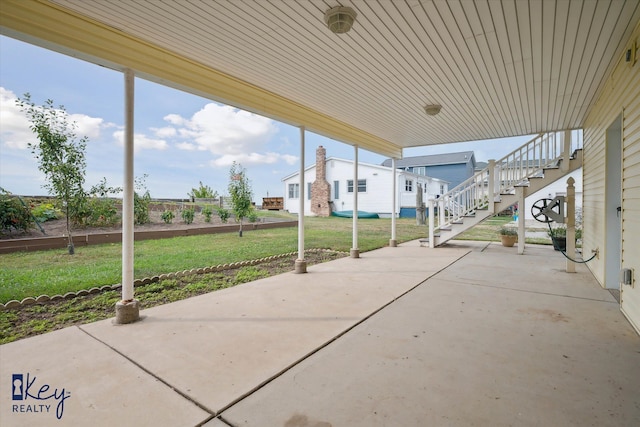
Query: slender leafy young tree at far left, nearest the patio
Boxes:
[{"xmin": 16, "ymin": 93, "xmax": 88, "ymax": 254}]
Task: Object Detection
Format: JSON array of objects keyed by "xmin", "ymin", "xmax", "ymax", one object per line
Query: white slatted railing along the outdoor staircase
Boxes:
[{"xmin": 429, "ymin": 131, "xmax": 582, "ymax": 244}]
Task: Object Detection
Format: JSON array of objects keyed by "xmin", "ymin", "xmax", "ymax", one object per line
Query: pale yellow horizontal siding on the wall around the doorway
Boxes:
[{"xmin": 583, "ymin": 20, "xmax": 640, "ymax": 330}]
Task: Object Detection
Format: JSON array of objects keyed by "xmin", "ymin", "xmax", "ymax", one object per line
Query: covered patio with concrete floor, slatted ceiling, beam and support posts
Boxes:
[{"xmin": 0, "ymin": 0, "xmax": 640, "ymax": 427}]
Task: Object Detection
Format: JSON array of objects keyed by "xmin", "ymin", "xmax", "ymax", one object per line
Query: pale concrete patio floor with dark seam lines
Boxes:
[{"xmin": 0, "ymin": 241, "xmax": 640, "ymax": 427}]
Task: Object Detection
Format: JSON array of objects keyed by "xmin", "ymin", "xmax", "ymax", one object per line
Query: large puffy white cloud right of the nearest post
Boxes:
[{"xmin": 164, "ymin": 103, "xmax": 278, "ymax": 160}]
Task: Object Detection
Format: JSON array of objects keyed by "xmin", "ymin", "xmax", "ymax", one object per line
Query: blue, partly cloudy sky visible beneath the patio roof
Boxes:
[{"xmin": 0, "ymin": 36, "xmax": 530, "ymax": 204}]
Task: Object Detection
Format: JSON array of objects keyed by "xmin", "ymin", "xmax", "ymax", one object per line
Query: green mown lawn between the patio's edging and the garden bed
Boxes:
[{"xmin": 0, "ymin": 217, "xmax": 427, "ymax": 303}]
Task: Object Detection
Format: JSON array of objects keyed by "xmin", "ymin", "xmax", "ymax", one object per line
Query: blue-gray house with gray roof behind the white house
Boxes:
[{"xmin": 382, "ymin": 151, "xmax": 476, "ymax": 189}]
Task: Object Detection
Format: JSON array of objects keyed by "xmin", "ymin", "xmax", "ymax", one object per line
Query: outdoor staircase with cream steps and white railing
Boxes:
[{"xmin": 422, "ymin": 131, "xmax": 582, "ymax": 247}]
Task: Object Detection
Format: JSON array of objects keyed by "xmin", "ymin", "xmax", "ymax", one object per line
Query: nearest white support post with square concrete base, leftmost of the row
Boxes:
[{"xmin": 115, "ymin": 69, "xmax": 140, "ymax": 324}]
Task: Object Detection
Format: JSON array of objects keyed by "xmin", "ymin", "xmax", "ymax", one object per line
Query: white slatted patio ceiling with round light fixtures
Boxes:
[{"xmin": 3, "ymin": 0, "xmax": 640, "ymax": 154}]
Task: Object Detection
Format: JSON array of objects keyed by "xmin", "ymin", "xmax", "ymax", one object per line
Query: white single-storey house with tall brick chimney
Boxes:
[{"xmin": 282, "ymin": 146, "xmax": 449, "ymax": 218}]
